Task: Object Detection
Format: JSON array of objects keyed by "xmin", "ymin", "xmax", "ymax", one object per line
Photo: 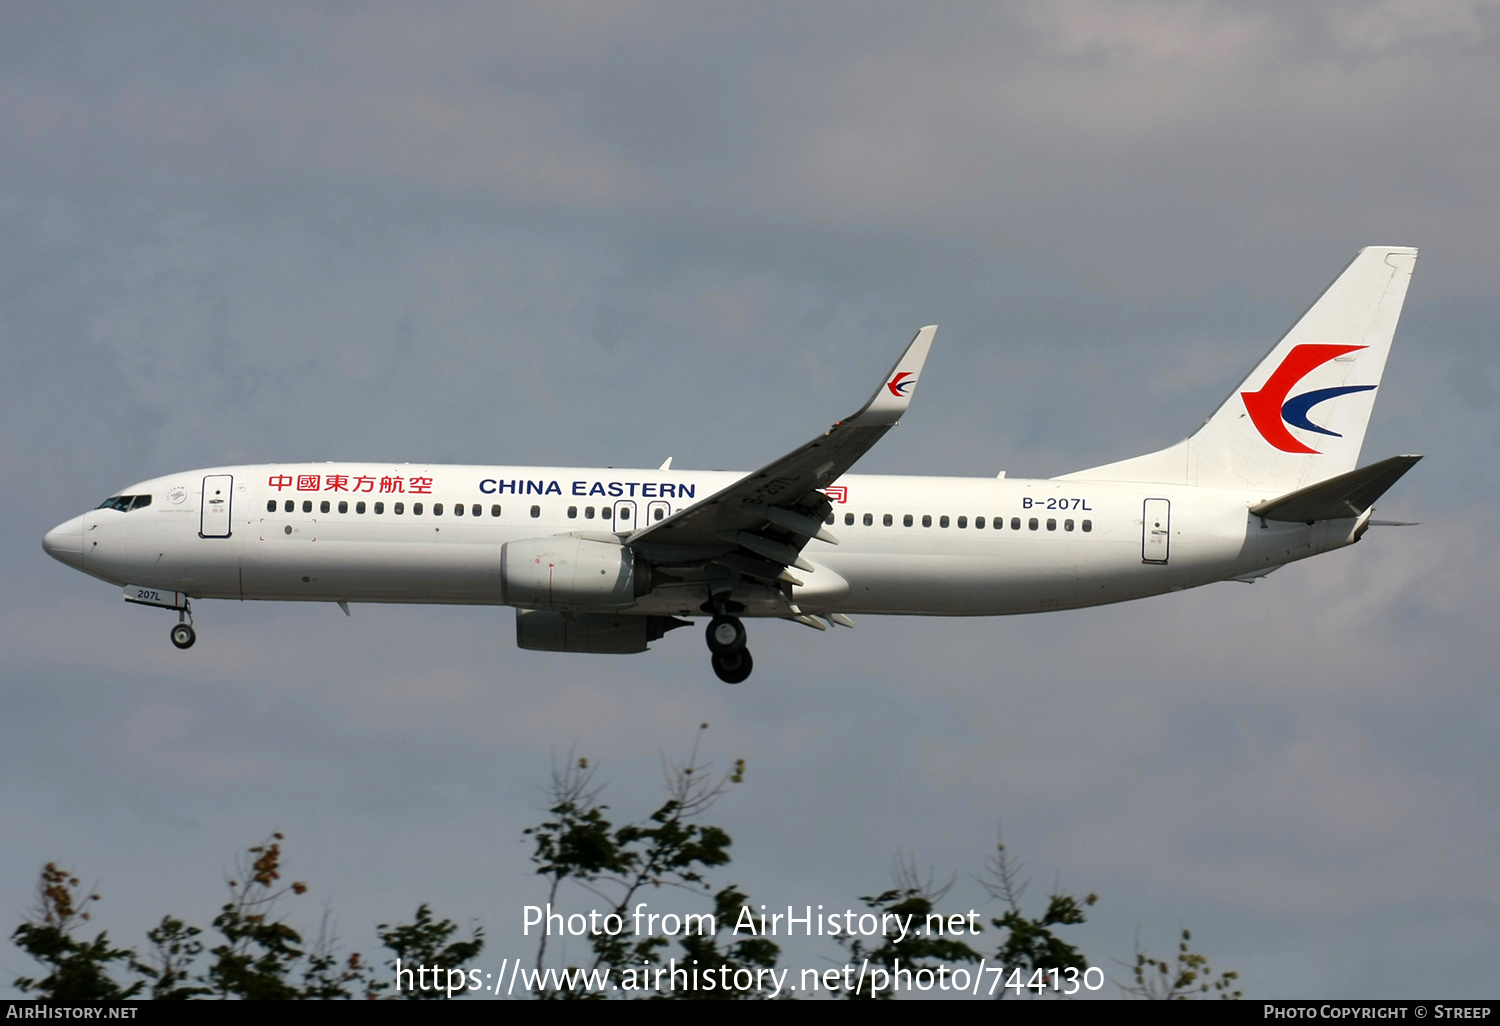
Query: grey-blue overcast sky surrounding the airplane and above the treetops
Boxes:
[{"xmin": 0, "ymin": 0, "xmax": 1500, "ymax": 998}]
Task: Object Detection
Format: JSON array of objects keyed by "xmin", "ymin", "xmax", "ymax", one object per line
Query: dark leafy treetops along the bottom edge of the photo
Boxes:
[{"xmin": 11, "ymin": 723, "xmax": 1241, "ymax": 1001}]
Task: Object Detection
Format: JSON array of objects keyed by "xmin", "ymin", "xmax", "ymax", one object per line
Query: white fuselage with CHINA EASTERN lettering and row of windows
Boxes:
[{"xmin": 47, "ymin": 464, "xmax": 1364, "ymax": 617}]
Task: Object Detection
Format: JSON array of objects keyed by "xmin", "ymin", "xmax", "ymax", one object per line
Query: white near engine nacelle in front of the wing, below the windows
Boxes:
[{"xmin": 500, "ymin": 534, "xmax": 651, "ymax": 609}]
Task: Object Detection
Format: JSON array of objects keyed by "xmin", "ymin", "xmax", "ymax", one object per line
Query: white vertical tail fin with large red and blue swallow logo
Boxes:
[{"xmin": 1064, "ymin": 246, "xmax": 1416, "ymax": 495}]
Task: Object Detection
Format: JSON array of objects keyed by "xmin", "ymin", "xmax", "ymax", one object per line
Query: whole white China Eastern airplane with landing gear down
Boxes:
[{"xmin": 42, "ymin": 246, "xmax": 1422, "ymax": 684}]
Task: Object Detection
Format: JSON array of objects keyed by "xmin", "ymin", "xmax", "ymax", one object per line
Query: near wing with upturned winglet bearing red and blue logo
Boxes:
[{"xmin": 626, "ymin": 326, "xmax": 938, "ymax": 584}]
